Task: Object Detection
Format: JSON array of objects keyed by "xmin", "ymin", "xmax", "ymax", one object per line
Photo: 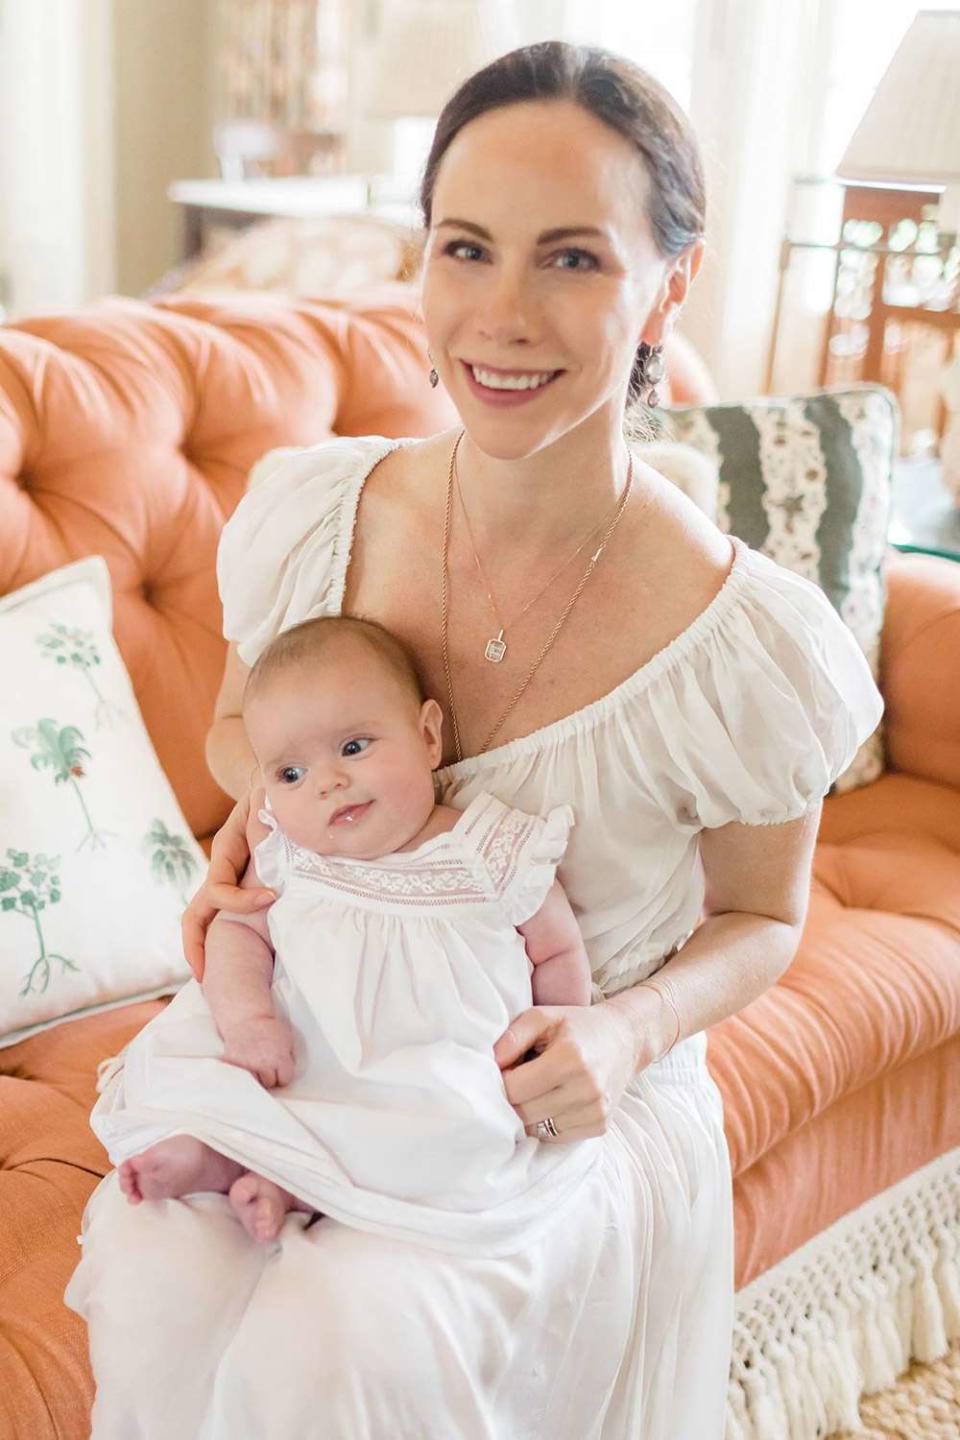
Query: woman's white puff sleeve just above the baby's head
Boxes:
[{"xmin": 217, "ymin": 435, "xmax": 396, "ymax": 665}]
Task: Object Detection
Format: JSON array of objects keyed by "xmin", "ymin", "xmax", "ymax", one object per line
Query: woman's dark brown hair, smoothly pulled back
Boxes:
[{"xmin": 420, "ymin": 40, "xmax": 707, "ymax": 417}]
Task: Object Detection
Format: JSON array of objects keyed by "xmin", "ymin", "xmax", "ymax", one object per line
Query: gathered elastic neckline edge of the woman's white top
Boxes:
[{"xmin": 330, "ymin": 435, "xmax": 753, "ymax": 783}]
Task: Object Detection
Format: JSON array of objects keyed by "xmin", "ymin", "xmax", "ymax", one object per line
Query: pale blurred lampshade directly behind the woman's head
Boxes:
[{"xmin": 364, "ymin": 0, "xmax": 518, "ymax": 120}]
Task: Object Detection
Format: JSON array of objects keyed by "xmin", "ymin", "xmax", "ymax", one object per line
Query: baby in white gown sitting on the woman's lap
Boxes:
[{"xmin": 92, "ymin": 618, "xmax": 592, "ymax": 1248}]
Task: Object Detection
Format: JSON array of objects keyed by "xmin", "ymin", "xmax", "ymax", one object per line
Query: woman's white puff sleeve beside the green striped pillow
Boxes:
[{"xmin": 642, "ymin": 547, "xmax": 882, "ymax": 828}]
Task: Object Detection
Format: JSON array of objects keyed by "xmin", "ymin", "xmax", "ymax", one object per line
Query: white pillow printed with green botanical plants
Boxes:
[{"xmin": 0, "ymin": 556, "xmax": 206, "ymax": 1045}]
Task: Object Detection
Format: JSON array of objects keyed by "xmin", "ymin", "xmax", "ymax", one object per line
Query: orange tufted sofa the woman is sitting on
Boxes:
[{"xmin": 0, "ymin": 287, "xmax": 960, "ymax": 1440}]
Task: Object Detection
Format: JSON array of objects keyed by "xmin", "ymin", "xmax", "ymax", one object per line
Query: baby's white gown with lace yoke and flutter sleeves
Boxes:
[{"xmin": 91, "ymin": 793, "xmax": 599, "ymax": 1256}]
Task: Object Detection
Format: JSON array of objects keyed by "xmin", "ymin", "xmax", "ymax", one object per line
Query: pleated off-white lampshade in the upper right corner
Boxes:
[{"xmin": 838, "ymin": 10, "xmax": 960, "ymax": 186}]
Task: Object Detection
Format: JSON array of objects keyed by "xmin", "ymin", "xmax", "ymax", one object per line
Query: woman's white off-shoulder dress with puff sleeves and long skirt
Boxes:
[{"xmin": 68, "ymin": 436, "xmax": 881, "ymax": 1440}]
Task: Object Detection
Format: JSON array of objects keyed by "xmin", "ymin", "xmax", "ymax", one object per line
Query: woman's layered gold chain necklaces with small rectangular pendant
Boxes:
[{"xmin": 440, "ymin": 431, "xmax": 633, "ymax": 760}]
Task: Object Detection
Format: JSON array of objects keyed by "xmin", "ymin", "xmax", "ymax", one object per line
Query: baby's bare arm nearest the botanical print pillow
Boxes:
[{"xmin": 203, "ymin": 828, "xmax": 295, "ymax": 1089}]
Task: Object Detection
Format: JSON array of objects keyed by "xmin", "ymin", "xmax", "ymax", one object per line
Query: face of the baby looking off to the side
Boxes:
[{"xmin": 243, "ymin": 638, "xmax": 442, "ymax": 860}]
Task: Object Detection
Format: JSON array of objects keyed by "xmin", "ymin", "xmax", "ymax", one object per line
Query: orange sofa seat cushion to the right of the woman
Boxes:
[{"xmin": 710, "ymin": 775, "xmax": 960, "ymax": 1175}]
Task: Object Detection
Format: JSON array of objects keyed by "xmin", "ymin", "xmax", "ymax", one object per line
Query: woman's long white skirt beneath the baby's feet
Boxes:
[{"xmin": 66, "ymin": 1034, "xmax": 734, "ymax": 1440}]
